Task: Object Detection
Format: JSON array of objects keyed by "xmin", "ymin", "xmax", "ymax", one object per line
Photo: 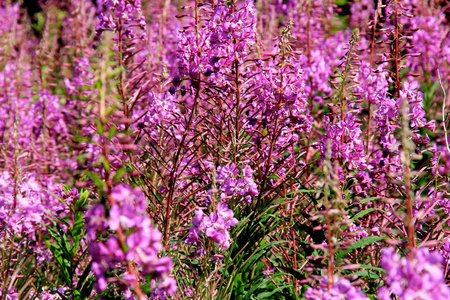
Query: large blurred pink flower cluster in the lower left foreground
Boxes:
[{"xmin": 87, "ymin": 185, "xmax": 176, "ymax": 292}]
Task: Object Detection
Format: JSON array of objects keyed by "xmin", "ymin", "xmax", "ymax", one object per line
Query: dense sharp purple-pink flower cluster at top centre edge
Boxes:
[{"xmin": 178, "ymin": 0, "xmax": 256, "ymax": 82}]
